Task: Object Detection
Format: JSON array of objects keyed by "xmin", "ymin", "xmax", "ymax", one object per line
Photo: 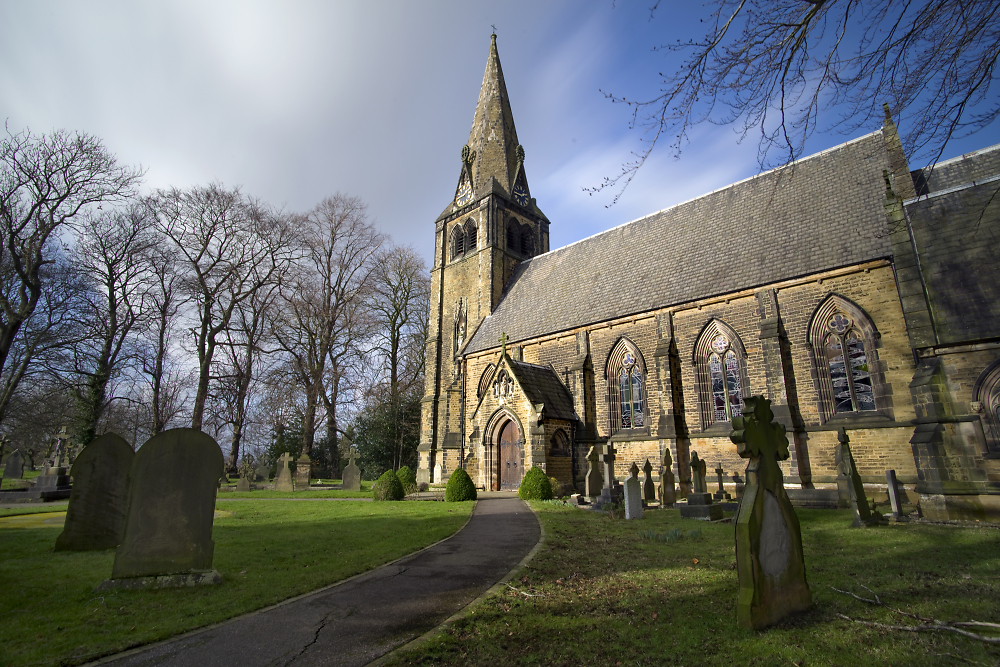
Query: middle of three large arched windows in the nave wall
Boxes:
[{"xmin": 694, "ymin": 320, "xmax": 750, "ymax": 428}]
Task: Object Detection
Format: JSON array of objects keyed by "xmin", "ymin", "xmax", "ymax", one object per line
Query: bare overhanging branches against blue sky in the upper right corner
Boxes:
[{"xmin": 587, "ymin": 0, "xmax": 1000, "ymax": 201}]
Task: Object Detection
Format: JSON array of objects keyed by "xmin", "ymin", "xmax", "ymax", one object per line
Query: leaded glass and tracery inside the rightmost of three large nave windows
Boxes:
[{"xmin": 825, "ymin": 313, "xmax": 875, "ymax": 412}]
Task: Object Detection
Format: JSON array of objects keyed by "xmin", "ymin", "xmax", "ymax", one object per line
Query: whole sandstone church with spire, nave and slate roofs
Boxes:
[{"xmin": 418, "ymin": 35, "xmax": 1000, "ymax": 520}]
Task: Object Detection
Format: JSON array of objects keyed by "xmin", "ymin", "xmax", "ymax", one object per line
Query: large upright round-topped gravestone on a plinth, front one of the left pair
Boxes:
[{"xmin": 98, "ymin": 428, "xmax": 225, "ymax": 590}]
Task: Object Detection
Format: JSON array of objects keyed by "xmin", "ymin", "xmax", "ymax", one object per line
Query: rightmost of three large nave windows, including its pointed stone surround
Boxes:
[{"xmin": 807, "ymin": 294, "xmax": 891, "ymax": 421}]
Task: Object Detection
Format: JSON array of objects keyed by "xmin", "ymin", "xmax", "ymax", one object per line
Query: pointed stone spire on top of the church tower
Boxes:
[{"xmin": 463, "ymin": 33, "xmax": 524, "ymax": 196}]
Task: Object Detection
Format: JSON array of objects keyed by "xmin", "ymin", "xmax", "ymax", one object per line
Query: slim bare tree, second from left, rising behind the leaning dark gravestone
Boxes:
[{"xmin": 74, "ymin": 204, "xmax": 157, "ymax": 443}]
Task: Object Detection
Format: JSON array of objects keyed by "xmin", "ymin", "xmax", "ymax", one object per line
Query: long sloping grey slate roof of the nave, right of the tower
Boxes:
[{"xmin": 466, "ymin": 131, "xmax": 891, "ymax": 353}]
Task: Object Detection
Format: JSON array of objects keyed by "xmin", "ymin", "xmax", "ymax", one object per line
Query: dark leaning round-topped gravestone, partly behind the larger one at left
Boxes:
[{"xmin": 55, "ymin": 433, "xmax": 135, "ymax": 551}]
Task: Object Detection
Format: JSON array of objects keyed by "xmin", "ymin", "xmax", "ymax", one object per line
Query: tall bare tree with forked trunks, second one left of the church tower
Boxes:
[{"xmin": 275, "ymin": 193, "xmax": 384, "ymax": 476}]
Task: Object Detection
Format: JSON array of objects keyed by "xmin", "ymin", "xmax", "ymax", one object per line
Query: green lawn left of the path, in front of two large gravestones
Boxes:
[{"xmin": 0, "ymin": 499, "xmax": 473, "ymax": 667}]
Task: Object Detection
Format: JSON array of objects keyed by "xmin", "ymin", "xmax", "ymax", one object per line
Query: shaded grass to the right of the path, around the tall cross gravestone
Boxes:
[{"xmin": 388, "ymin": 501, "xmax": 1000, "ymax": 667}]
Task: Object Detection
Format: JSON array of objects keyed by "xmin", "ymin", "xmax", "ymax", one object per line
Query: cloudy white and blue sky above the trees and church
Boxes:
[{"xmin": 0, "ymin": 0, "xmax": 1000, "ymax": 260}]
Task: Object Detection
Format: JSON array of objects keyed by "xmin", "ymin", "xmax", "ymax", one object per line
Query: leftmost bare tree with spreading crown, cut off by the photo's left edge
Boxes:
[{"xmin": 0, "ymin": 130, "xmax": 142, "ymax": 399}]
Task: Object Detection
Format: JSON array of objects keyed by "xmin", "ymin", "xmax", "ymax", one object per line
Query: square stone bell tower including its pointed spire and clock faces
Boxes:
[{"xmin": 417, "ymin": 34, "xmax": 549, "ymax": 483}]
